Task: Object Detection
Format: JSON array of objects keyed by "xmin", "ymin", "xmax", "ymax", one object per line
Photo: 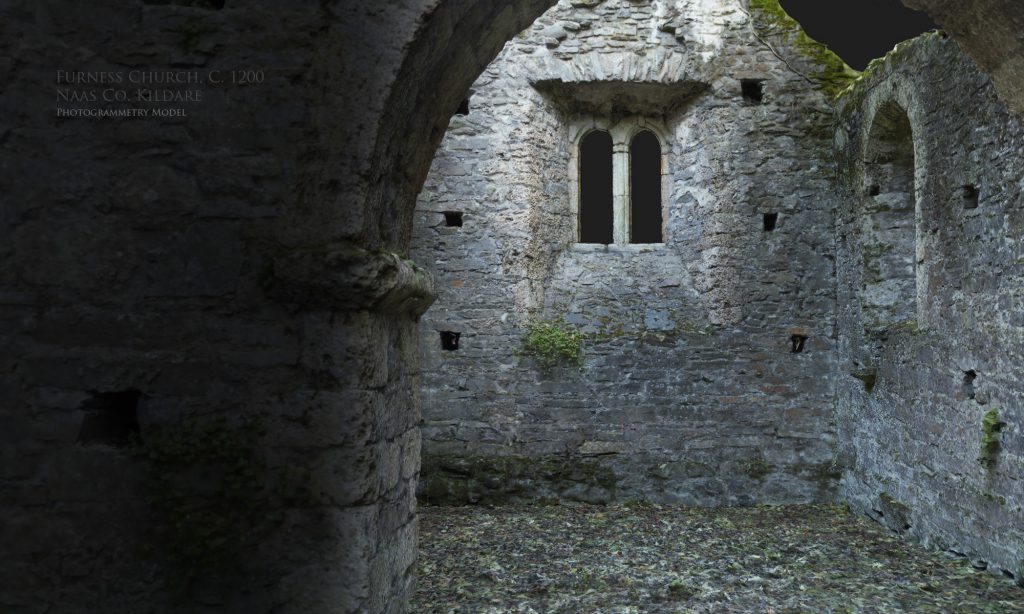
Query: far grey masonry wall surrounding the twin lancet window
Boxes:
[{"xmin": 411, "ymin": 0, "xmax": 839, "ymax": 506}]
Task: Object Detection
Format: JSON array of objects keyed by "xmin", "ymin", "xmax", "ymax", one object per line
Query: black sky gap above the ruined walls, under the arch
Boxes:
[{"xmin": 779, "ymin": 0, "xmax": 937, "ymax": 71}]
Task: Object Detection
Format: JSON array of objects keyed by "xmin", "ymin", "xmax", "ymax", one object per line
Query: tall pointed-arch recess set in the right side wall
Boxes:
[{"xmin": 860, "ymin": 101, "xmax": 920, "ymax": 338}]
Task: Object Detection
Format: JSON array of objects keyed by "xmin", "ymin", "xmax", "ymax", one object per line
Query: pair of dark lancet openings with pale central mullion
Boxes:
[{"xmin": 579, "ymin": 130, "xmax": 665, "ymax": 245}]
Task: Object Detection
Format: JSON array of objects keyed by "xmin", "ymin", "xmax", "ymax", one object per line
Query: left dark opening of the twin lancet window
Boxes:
[{"xmin": 580, "ymin": 130, "xmax": 614, "ymax": 245}]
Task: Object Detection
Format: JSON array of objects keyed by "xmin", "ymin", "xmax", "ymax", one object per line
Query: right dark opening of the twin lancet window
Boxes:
[{"xmin": 630, "ymin": 130, "xmax": 662, "ymax": 244}]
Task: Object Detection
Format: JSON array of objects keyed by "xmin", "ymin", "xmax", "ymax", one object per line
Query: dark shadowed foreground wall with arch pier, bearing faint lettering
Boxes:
[{"xmin": 0, "ymin": 0, "xmax": 561, "ymax": 613}]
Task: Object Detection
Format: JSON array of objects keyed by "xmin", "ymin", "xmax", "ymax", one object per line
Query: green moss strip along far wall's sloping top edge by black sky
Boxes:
[{"xmin": 751, "ymin": 0, "xmax": 860, "ymax": 98}]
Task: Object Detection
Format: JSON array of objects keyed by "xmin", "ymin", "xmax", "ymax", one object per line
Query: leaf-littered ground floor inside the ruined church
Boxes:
[{"xmin": 410, "ymin": 505, "xmax": 1024, "ymax": 613}]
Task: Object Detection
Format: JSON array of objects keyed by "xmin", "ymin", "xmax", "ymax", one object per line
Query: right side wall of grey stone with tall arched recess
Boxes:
[{"xmin": 837, "ymin": 35, "xmax": 1024, "ymax": 578}]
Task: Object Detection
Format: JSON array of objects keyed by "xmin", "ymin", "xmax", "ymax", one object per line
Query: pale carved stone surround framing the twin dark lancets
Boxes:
[{"xmin": 568, "ymin": 116, "xmax": 672, "ymax": 248}]
